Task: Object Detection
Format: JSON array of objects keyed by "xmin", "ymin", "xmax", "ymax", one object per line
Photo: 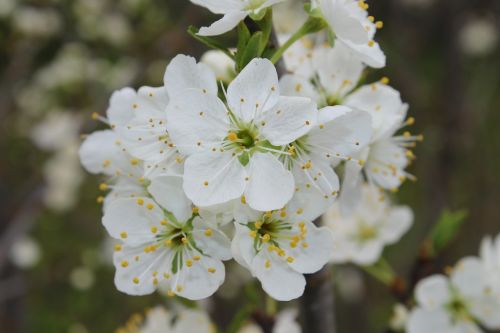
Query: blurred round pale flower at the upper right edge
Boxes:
[{"xmin": 459, "ymin": 17, "xmax": 500, "ymax": 56}]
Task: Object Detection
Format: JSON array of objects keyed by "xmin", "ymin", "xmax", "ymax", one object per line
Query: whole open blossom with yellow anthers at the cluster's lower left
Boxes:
[{"xmin": 103, "ymin": 195, "xmax": 231, "ymax": 300}]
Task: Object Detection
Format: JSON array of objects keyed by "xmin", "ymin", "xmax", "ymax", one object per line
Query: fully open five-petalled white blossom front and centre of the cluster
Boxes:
[{"xmin": 167, "ymin": 59, "xmax": 317, "ymax": 211}]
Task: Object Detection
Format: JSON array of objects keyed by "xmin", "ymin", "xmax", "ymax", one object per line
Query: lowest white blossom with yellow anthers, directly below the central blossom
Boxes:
[{"xmin": 231, "ymin": 209, "xmax": 332, "ymax": 301}]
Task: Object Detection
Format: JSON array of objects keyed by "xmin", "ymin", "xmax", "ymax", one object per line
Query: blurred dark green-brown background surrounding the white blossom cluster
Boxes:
[{"xmin": 0, "ymin": 0, "xmax": 500, "ymax": 333}]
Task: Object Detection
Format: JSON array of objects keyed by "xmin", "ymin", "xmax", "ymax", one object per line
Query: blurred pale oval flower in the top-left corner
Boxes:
[{"xmin": 12, "ymin": 7, "xmax": 62, "ymax": 37}]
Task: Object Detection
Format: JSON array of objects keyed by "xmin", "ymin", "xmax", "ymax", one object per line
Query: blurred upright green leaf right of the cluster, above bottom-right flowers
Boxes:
[{"xmin": 429, "ymin": 209, "xmax": 467, "ymax": 256}]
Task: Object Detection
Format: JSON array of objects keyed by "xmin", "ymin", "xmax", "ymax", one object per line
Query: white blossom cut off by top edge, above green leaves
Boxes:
[{"xmin": 191, "ymin": 0, "xmax": 286, "ymax": 36}]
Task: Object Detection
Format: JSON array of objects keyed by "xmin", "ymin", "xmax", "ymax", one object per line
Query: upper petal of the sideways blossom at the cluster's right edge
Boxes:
[{"xmin": 344, "ymin": 83, "xmax": 407, "ymax": 141}]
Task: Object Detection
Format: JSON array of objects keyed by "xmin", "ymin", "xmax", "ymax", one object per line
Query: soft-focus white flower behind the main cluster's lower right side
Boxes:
[{"xmin": 323, "ymin": 185, "xmax": 413, "ymax": 266}]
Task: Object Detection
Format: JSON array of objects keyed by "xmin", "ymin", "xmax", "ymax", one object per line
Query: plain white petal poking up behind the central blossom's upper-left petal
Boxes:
[{"xmin": 163, "ymin": 54, "xmax": 217, "ymax": 99}]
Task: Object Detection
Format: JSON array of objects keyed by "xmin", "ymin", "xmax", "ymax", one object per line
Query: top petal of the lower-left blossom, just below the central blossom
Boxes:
[{"xmin": 148, "ymin": 176, "xmax": 192, "ymax": 221}]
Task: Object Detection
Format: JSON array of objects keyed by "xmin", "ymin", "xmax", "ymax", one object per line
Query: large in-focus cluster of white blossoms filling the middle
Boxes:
[{"xmin": 80, "ymin": 0, "xmax": 419, "ymax": 301}]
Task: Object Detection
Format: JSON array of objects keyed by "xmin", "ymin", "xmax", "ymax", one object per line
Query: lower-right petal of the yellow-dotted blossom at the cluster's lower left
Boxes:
[{"xmin": 172, "ymin": 256, "xmax": 226, "ymax": 300}]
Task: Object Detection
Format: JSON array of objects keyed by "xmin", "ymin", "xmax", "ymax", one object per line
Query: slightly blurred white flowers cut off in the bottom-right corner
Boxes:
[{"xmin": 406, "ymin": 235, "xmax": 500, "ymax": 333}]
